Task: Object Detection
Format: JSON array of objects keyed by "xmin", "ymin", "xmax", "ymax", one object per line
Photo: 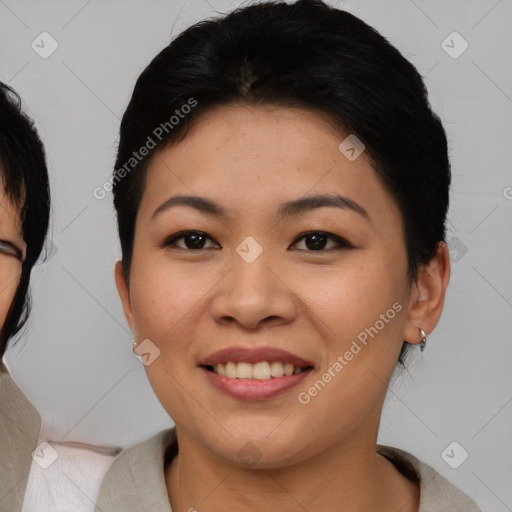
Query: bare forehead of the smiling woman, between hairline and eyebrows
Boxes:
[{"xmin": 141, "ymin": 105, "xmax": 400, "ymax": 222}]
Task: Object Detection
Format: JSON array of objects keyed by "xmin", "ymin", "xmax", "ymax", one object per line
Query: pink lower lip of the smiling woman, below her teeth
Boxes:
[{"xmin": 202, "ymin": 368, "xmax": 311, "ymax": 400}]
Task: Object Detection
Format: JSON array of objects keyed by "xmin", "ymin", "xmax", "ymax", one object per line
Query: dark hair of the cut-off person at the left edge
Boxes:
[{"xmin": 0, "ymin": 82, "xmax": 50, "ymax": 359}]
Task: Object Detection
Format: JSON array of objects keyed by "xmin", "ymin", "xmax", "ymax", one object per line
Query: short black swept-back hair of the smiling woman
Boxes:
[{"xmin": 113, "ymin": 0, "xmax": 450, "ymax": 360}]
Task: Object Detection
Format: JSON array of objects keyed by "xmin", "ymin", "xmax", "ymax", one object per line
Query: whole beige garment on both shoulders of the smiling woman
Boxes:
[{"xmin": 95, "ymin": 428, "xmax": 480, "ymax": 512}]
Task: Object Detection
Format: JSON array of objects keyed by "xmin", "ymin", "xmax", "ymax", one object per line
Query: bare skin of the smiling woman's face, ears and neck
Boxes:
[{"xmin": 115, "ymin": 104, "xmax": 450, "ymax": 512}]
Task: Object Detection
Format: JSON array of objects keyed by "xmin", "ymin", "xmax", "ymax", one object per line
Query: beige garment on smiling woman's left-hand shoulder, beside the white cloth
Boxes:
[{"xmin": 95, "ymin": 428, "xmax": 177, "ymax": 512}]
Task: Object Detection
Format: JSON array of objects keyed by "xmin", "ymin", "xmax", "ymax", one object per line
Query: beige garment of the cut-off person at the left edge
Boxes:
[{"xmin": 0, "ymin": 362, "xmax": 41, "ymax": 512}]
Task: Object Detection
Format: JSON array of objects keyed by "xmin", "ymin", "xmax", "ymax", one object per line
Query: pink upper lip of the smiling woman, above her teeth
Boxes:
[{"xmin": 200, "ymin": 347, "xmax": 313, "ymax": 367}]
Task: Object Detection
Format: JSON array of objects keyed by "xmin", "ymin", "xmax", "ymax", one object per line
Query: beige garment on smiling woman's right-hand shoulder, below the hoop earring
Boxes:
[{"xmin": 377, "ymin": 445, "xmax": 481, "ymax": 512}]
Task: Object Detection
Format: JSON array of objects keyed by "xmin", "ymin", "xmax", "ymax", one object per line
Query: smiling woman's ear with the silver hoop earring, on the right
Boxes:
[{"xmin": 404, "ymin": 242, "xmax": 450, "ymax": 344}]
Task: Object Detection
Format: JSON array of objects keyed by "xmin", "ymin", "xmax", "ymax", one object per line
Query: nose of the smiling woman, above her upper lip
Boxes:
[{"xmin": 210, "ymin": 251, "xmax": 297, "ymax": 330}]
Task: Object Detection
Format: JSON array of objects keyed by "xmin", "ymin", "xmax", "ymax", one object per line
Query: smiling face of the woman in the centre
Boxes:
[{"xmin": 116, "ymin": 105, "xmax": 444, "ymax": 467}]
